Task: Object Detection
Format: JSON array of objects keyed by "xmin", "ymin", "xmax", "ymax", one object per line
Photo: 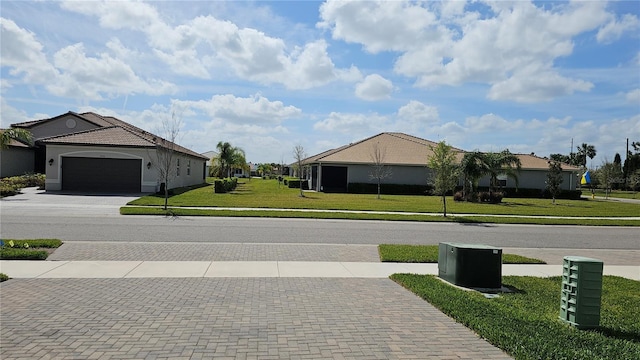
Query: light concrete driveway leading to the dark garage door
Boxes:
[{"xmin": 0, "ymin": 187, "xmax": 144, "ymax": 216}]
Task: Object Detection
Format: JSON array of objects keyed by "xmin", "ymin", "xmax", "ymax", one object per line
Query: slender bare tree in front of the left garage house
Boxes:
[{"xmin": 154, "ymin": 112, "xmax": 182, "ymax": 210}]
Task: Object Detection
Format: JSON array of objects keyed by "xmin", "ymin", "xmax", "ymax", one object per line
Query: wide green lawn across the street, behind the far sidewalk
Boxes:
[{"xmin": 129, "ymin": 179, "xmax": 640, "ymax": 217}]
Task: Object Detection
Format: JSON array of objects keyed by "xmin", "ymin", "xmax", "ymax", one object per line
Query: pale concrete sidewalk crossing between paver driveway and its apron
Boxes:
[{"xmin": 0, "ymin": 260, "xmax": 640, "ymax": 281}]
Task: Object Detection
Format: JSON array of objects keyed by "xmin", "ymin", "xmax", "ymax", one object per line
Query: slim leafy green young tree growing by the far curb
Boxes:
[{"xmin": 428, "ymin": 141, "xmax": 459, "ymax": 217}]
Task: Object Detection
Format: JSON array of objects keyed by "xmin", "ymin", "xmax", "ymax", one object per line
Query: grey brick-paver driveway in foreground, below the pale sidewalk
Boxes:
[{"xmin": 0, "ymin": 278, "xmax": 508, "ymax": 359}]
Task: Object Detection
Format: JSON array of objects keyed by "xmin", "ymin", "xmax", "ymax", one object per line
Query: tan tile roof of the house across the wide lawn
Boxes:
[{"xmin": 303, "ymin": 132, "xmax": 580, "ymax": 171}]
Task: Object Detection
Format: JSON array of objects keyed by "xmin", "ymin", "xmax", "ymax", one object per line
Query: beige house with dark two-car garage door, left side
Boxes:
[{"xmin": 3, "ymin": 112, "xmax": 207, "ymax": 193}]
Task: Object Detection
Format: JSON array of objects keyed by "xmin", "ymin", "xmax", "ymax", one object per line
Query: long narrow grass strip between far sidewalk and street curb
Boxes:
[{"xmin": 120, "ymin": 206, "xmax": 640, "ymax": 226}]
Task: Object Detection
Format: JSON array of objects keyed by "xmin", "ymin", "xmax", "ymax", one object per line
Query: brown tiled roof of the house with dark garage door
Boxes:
[{"xmin": 11, "ymin": 111, "xmax": 205, "ymax": 159}]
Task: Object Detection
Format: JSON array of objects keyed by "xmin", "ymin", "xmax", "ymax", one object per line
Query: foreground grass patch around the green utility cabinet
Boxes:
[{"xmin": 391, "ymin": 274, "xmax": 640, "ymax": 360}]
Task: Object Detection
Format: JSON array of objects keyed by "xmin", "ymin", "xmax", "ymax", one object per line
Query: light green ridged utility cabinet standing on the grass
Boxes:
[{"xmin": 560, "ymin": 256, "xmax": 603, "ymax": 329}]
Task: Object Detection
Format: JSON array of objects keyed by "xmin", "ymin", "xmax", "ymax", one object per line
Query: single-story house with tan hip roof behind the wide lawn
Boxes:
[{"xmin": 303, "ymin": 132, "xmax": 580, "ymax": 192}]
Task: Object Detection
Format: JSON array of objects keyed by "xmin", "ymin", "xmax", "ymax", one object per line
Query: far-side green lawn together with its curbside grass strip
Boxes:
[{"xmin": 121, "ymin": 179, "xmax": 640, "ymax": 225}]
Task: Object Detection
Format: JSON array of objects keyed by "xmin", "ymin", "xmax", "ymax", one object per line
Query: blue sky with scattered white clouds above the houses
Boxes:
[{"xmin": 0, "ymin": 1, "xmax": 640, "ymax": 167}]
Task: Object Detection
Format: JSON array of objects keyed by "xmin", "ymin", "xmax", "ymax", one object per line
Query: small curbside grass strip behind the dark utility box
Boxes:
[{"xmin": 378, "ymin": 244, "xmax": 546, "ymax": 264}]
